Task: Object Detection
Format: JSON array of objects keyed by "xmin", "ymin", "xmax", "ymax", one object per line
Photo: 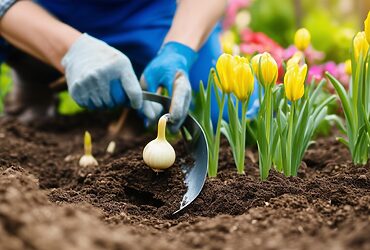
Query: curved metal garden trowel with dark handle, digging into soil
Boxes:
[{"xmin": 143, "ymin": 91, "xmax": 208, "ymax": 214}]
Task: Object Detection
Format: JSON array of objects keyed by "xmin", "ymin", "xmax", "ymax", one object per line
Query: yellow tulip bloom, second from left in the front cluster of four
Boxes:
[{"xmin": 233, "ymin": 60, "xmax": 254, "ymax": 101}]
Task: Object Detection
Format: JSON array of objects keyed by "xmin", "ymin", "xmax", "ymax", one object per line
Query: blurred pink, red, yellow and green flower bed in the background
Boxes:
[{"xmin": 221, "ymin": 0, "xmax": 370, "ymax": 89}]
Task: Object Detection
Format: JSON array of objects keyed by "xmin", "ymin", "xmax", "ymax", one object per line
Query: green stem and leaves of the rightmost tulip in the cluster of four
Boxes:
[{"xmin": 274, "ymin": 81, "xmax": 335, "ymax": 176}]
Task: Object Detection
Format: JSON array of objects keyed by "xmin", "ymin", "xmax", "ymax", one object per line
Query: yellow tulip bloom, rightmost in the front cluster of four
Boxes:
[{"xmin": 284, "ymin": 64, "xmax": 307, "ymax": 102}]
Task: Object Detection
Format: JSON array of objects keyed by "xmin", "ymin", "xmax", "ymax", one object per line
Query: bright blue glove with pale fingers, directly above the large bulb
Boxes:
[{"xmin": 142, "ymin": 42, "xmax": 197, "ymax": 132}]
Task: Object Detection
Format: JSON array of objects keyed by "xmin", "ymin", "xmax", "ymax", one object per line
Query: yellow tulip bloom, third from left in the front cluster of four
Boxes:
[{"xmin": 252, "ymin": 52, "xmax": 278, "ymax": 88}]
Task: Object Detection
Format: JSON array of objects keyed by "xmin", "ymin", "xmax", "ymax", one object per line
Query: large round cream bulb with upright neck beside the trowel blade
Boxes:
[{"xmin": 143, "ymin": 114, "xmax": 176, "ymax": 172}]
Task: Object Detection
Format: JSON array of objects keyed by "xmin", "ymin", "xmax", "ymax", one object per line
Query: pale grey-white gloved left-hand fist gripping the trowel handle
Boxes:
[{"xmin": 62, "ymin": 34, "xmax": 142, "ymax": 109}]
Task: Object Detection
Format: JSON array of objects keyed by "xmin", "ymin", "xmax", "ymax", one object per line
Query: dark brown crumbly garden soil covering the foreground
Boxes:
[{"xmin": 0, "ymin": 114, "xmax": 370, "ymax": 250}]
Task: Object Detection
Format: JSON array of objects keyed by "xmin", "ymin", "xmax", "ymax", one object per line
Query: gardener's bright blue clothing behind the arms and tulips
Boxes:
[{"xmin": 0, "ymin": 0, "xmax": 257, "ymax": 121}]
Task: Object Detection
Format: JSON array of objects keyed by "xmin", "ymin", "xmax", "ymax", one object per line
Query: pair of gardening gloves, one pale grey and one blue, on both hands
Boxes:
[{"xmin": 62, "ymin": 34, "xmax": 197, "ymax": 130}]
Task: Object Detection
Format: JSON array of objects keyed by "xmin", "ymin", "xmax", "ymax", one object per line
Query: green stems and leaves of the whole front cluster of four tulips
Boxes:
[{"xmin": 194, "ymin": 61, "xmax": 332, "ymax": 180}]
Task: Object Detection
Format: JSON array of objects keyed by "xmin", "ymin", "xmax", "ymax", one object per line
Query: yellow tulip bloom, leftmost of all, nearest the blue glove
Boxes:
[{"xmin": 214, "ymin": 53, "xmax": 236, "ymax": 94}]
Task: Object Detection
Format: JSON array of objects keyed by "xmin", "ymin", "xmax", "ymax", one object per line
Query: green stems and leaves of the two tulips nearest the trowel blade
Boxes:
[{"xmin": 193, "ymin": 69, "xmax": 253, "ymax": 177}]
